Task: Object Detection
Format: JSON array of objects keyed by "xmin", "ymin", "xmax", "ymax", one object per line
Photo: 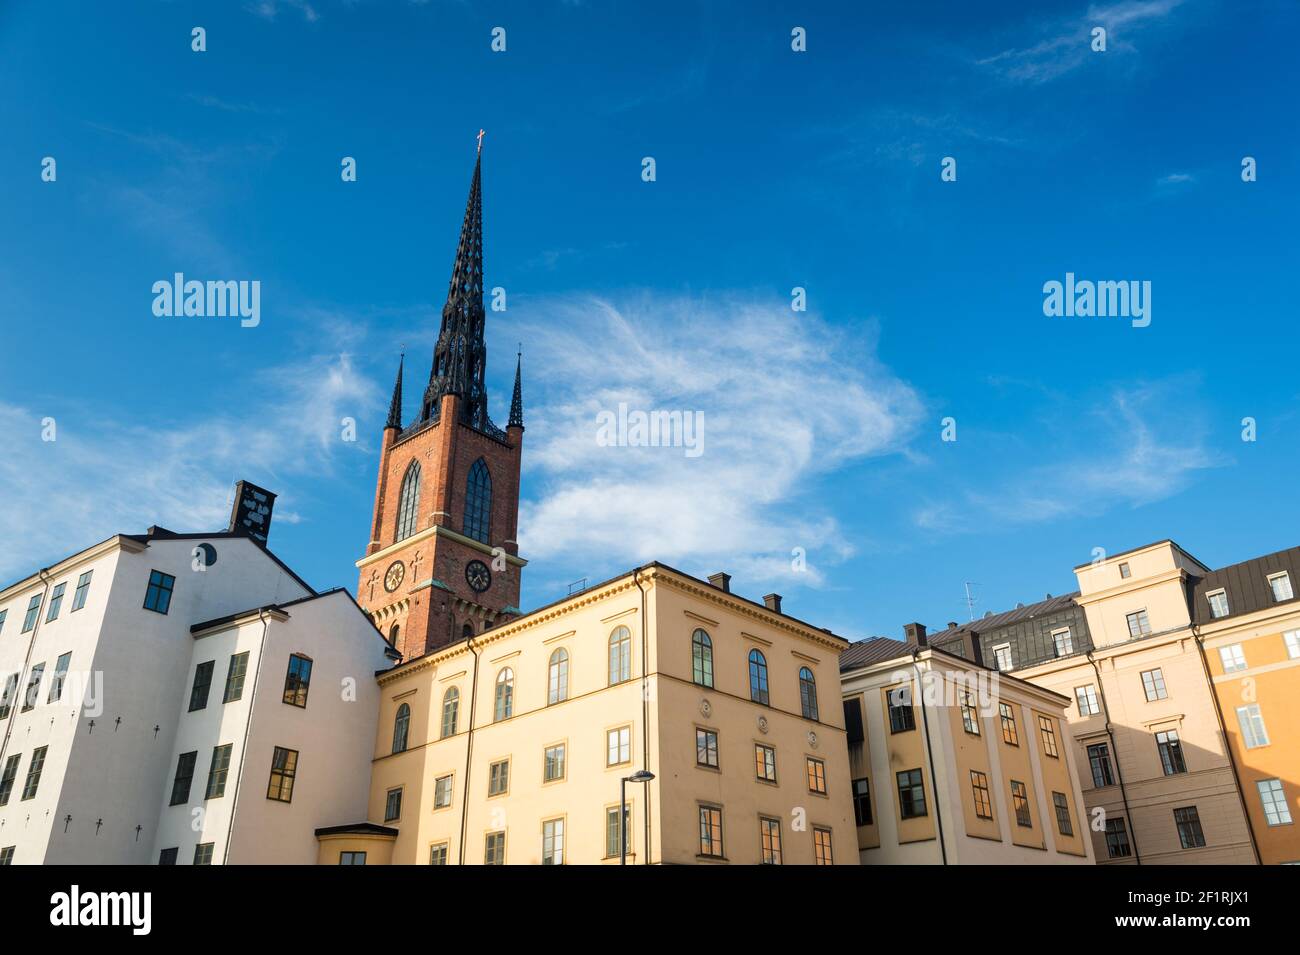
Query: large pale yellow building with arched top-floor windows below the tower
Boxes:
[{"xmin": 317, "ymin": 564, "xmax": 858, "ymax": 864}]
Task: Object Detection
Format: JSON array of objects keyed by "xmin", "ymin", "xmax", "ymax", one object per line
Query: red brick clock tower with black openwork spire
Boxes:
[{"xmin": 356, "ymin": 136, "xmax": 528, "ymax": 660}]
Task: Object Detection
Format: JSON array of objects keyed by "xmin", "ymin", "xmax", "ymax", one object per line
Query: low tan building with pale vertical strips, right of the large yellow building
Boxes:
[{"xmin": 841, "ymin": 634, "xmax": 1093, "ymax": 865}]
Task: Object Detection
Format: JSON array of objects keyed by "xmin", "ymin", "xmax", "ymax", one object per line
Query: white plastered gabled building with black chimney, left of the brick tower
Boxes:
[{"xmin": 0, "ymin": 486, "xmax": 391, "ymax": 864}]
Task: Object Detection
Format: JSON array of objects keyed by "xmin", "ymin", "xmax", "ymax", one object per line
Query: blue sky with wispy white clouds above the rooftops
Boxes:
[{"xmin": 0, "ymin": 0, "xmax": 1300, "ymax": 638}]
